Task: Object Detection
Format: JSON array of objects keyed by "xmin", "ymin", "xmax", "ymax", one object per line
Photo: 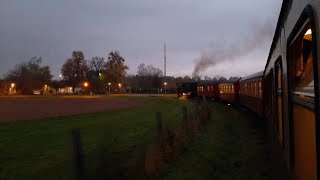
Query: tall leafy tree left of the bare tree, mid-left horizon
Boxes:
[{"xmin": 61, "ymin": 51, "xmax": 88, "ymax": 91}]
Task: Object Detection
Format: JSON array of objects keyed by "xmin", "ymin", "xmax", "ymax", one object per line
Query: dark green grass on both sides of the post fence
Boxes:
[{"xmin": 0, "ymin": 97, "xmax": 269, "ymax": 179}]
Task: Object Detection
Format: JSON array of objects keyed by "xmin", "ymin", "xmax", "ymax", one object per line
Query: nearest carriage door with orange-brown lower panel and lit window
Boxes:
[{"xmin": 288, "ymin": 20, "xmax": 318, "ymax": 180}]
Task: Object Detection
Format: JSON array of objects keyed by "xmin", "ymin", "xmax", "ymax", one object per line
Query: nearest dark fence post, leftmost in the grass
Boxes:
[{"xmin": 72, "ymin": 129, "xmax": 85, "ymax": 180}]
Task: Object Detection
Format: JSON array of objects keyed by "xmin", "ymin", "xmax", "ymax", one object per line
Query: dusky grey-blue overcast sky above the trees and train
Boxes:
[{"xmin": 0, "ymin": 0, "xmax": 282, "ymax": 78}]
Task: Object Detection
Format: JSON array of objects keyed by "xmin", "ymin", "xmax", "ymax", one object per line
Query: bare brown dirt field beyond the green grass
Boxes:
[{"xmin": 0, "ymin": 96, "xmax": 145, "ymax": 122}]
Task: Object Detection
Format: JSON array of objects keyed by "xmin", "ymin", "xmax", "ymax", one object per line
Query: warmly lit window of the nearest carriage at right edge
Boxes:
[{"xmin": 290, "ymin": 24, "xmax": 314, "ymax": 101}]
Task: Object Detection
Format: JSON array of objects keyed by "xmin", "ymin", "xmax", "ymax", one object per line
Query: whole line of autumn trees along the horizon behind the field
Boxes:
[{"xmin": 5, "ymin": 51, "xmax": 240, "ymax": 94}]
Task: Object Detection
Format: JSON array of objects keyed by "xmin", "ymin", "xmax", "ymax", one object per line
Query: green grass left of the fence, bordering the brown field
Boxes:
[{"xmin": 0, "ymin": 97, "xmax": 192, "ymax": 179}]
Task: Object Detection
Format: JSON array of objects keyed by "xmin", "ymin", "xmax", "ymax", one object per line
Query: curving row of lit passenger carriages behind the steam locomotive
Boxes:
[{"xmin": 179, "ymin": 0, "xmax": 320, "ymax": 180}]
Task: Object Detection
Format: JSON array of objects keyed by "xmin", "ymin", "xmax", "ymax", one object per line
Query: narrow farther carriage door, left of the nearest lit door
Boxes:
[{"xmin": 275, "ymin": 59, "xmax": 284, "ymax": 148}]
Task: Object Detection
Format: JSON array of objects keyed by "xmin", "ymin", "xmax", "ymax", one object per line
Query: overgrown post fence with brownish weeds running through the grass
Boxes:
[{"xmin": 72, "ymin": 101, "xmax": 211, "ymax": 180}]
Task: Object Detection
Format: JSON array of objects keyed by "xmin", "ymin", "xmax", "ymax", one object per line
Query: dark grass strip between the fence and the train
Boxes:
[{"xmin": 156, "ymin": 104, "xmax": 271, "ymax": 180}]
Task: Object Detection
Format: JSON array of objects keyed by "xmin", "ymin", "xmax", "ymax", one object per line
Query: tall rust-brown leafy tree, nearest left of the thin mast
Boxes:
[{"xmin": 104, "ymin": 51, "xmax": 129, "ymax": 86}]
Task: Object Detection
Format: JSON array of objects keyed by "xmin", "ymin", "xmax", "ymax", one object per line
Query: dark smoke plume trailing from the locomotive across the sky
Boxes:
[{"xmin": 192, "ymin": 20, "xmax": 274, "ymax": 77}]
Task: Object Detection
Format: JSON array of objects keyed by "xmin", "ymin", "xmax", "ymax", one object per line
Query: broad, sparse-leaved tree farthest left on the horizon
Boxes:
[{"xmin": 5, "ymin": 57, "xmax": 53, "ymax": 94}]
